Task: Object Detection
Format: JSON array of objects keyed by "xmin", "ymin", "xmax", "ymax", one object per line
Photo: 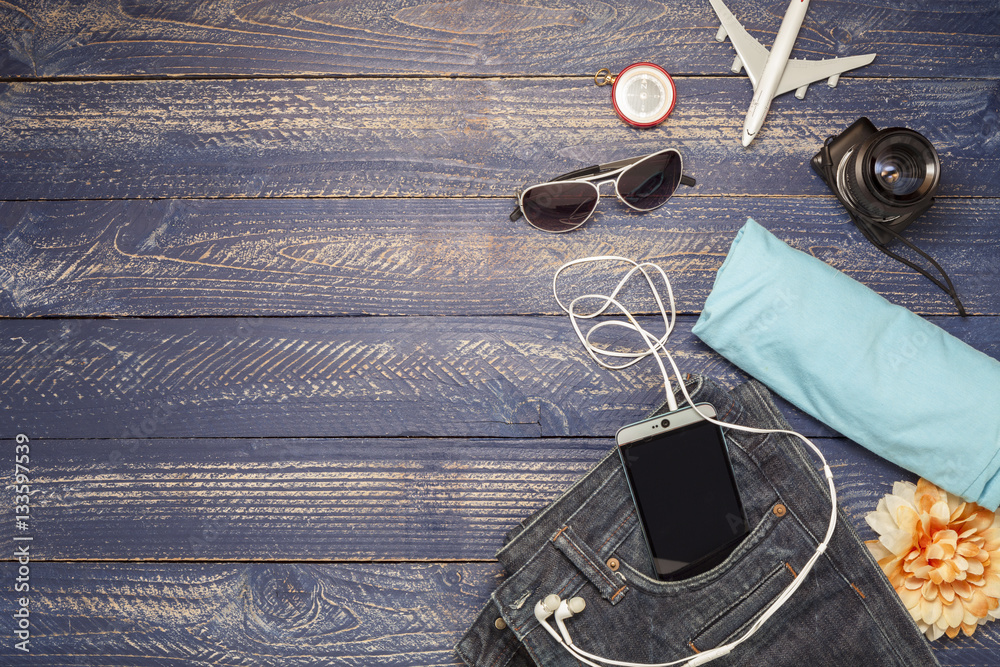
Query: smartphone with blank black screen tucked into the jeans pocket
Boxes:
[{"xmin": 618, "ymin": 406, "xmax": 749, "ymax": 579}]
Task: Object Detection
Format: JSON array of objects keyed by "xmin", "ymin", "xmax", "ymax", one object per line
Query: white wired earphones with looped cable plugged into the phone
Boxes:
[{"xmin": 535, "ymin": 255, "xmax": 837, "ymax": 667}]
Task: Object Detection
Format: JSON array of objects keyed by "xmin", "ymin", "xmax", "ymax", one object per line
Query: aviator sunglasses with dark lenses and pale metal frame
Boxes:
[{"xmin": 510, "ymin": 148, "xmax": 695, "ymax": 233}]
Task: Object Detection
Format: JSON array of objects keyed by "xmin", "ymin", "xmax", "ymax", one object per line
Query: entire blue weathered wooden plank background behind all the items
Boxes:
[{"xmin": 0, "ymin": 0, "xmax": 1000, "ymax": 666}]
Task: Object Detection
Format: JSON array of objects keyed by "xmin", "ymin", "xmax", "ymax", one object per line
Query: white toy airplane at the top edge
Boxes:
[{"xmin": 709, "ymin": 0, "xmax": 875, "ymax": 146}]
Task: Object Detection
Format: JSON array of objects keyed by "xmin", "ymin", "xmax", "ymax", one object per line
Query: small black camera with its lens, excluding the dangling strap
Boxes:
[{"xmin": 810, "ymin": 118, "xmax": 941, "ymax": 245}]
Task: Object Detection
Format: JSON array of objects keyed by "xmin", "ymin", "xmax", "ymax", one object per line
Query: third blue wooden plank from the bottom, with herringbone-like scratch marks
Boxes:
[{"xmin": 0, "ymin": 317, "xmax": 1000, "ymax": 439}]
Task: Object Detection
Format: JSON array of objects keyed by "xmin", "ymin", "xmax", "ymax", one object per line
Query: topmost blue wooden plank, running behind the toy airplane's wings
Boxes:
[{"xmin": 0, "ymin": 0, "xmax": 1000, "ymax": 78}]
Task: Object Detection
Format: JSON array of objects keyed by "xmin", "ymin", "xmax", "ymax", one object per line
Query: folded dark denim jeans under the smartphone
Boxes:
[{"xmin": 456, "ymin": 376, "xmax": 938, "ymax": 667}]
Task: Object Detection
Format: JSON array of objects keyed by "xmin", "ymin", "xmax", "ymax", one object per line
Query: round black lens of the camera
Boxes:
[{"xmin": 843, "ymin": 127, "xmax": 941, "ymax": 219}]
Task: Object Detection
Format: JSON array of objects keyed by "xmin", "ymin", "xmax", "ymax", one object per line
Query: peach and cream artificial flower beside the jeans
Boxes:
[{"xmin": 865, "ymin": 479, "xmax": 1000, "ymax": 639}]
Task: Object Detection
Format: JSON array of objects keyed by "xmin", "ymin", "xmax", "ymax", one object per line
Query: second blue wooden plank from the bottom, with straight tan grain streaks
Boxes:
[{"xmin": 0, "ymin": 438, "xmax": 952, "ymax": 561}]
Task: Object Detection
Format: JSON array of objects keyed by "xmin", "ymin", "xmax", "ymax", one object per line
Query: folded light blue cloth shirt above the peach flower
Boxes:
[{"xmin": 694, "ymin": 220, "xmax": 1000, "ymax": 510}]
